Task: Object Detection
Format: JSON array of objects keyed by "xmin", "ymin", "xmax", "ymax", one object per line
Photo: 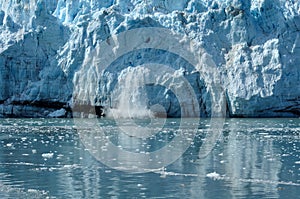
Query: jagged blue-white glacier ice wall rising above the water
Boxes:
[{"xmin": 0, "ymin": 0, "xmax": 300, "ymax": 117}]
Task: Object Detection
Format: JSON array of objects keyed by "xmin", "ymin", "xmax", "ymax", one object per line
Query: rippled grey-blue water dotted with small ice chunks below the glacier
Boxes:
[{"xmin": 0, "ymin": 119, "xmax": 300, "ymax": 198}]
